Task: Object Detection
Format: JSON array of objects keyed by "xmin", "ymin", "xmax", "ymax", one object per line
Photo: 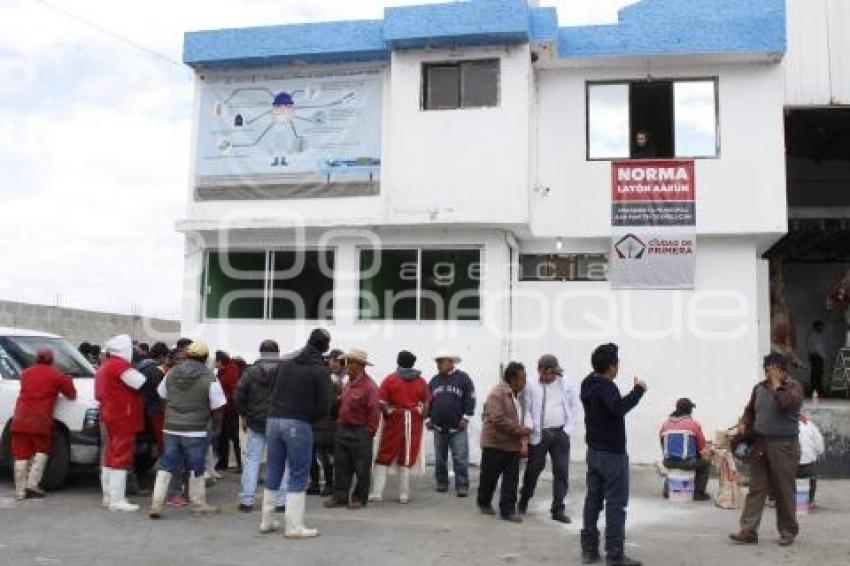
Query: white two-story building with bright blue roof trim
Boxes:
[{"xmin": 179, "ymin": 0, "xmax": 844, "ymax": 462}]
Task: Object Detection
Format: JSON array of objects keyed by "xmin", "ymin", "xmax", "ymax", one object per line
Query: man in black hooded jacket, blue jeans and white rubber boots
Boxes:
[{"xmin": 260, "ymin": 328, "xmax": 331, "ymax": 538}]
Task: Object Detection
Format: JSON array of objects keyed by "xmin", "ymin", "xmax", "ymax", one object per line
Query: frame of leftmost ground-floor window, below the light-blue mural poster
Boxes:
[{"xmin": 199, "ymin": 245, "xmax": 339, "ymax": 324}]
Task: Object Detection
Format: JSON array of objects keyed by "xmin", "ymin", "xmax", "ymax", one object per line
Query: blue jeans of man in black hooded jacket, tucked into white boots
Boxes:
[{"xmin": 266, "ymin": 419, "xmax": 313, "ymax": 493}]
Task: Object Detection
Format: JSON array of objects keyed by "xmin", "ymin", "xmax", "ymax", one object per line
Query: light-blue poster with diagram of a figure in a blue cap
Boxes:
[{"xmin": 196, "ymin": 67, "xmax": 383, "ymax": 195}]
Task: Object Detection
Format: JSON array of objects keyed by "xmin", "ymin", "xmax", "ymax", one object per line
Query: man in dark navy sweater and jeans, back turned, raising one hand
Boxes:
[{"xmin": 581, "ymin": 344, "xmax": 646, "ymax": 566}]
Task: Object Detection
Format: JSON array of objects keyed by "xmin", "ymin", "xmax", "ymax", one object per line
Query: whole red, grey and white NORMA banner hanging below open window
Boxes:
[{"xmin": 610, "ymin": 160, "xmax": 696, "ymax": 289}]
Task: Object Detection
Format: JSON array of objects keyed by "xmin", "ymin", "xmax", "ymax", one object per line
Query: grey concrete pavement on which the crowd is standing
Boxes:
[{"xmin": 0, "ymin": 465, "xmax": 850, "ymax": 566}]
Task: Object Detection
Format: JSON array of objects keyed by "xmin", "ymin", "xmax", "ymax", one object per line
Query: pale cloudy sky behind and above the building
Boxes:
[{"xmin": 0, "ymin": 0, "xmax": 634, "ymax": 318}]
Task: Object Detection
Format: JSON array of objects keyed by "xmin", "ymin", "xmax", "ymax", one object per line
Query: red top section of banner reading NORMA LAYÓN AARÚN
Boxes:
[{"xmin": 611, "ymin": 160, "xmax": 696, "ymax": 203}]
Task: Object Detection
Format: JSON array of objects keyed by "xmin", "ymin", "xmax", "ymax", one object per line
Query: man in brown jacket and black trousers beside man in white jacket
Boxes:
[{"xmin": 478, "ymin": 362, "xmax": 531, "ymax": 523}]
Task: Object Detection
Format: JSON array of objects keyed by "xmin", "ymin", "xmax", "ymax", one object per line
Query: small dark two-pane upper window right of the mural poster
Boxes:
[{"xmin": 422, "ymin": 59, "xmax": 499, "ymax": 110}]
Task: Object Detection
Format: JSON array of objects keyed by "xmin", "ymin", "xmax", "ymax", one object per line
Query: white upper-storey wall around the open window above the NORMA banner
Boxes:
[{"xmin": 530, "ymin": 63, "xmax": 786, "ymax": 237}]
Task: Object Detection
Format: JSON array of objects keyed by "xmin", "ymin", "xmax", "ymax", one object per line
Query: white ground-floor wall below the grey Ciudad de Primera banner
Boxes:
[{"xmin": 515, "ymin": 237, "xmax": 763, "ymax": 463}]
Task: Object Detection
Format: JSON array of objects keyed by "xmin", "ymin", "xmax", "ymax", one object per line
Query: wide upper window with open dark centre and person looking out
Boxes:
[{"xmin": 587, "ymin": 79, "xmax": 720, "ymax": 159}]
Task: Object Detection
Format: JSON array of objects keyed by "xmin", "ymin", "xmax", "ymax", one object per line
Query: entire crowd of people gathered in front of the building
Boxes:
[{"xmin": 6, "ymin": 329, "xmax": 823, "ymax": 564}]
